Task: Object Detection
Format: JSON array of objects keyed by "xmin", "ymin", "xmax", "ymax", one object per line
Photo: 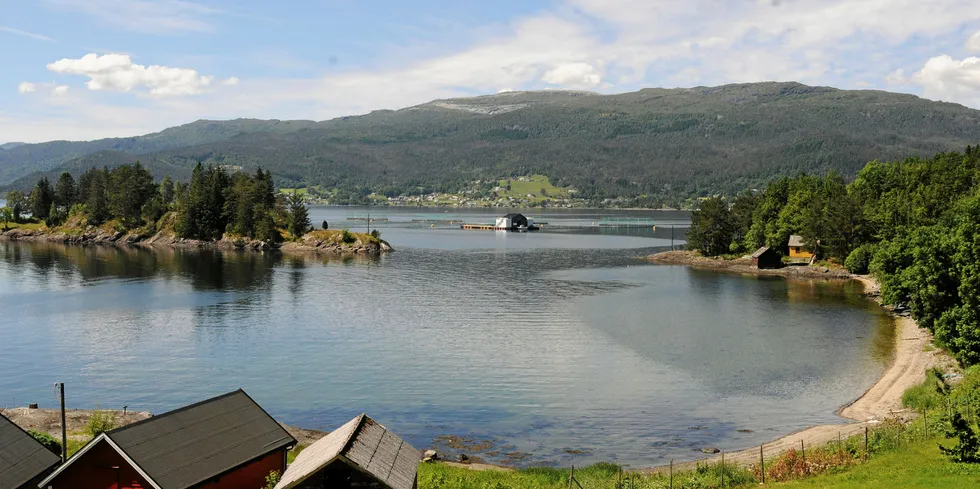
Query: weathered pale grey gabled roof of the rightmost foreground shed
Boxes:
[{"xmin": 276, "ymin": 414, "xmax": 419, "ymax": 489}]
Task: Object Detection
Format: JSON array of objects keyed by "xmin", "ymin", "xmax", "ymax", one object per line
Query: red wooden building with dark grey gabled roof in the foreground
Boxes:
[{"xmin": 39, "ymin": 389, "xmax": 296, "ymax": 489}]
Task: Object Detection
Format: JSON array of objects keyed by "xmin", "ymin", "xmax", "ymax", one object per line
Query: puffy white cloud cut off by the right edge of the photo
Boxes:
[{"xmin": 910, "ymin": 55, "xmax": 980, "ymax": 104}]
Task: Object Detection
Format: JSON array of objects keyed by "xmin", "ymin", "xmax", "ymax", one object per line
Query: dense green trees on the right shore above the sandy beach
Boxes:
[{"xmin": 688, "ymin": 146, "xmax": 980, "ymax": 365}]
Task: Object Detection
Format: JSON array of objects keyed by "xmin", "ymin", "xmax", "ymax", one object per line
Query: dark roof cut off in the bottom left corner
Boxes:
[{"xmin": 0, "ymin": 414, "xmax": 61, "ymax": 489}]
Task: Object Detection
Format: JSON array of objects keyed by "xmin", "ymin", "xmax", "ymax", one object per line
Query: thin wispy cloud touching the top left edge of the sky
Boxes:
[{"xmin": 45, "ymin": 0, "xmax": 221, "ymax": 34}]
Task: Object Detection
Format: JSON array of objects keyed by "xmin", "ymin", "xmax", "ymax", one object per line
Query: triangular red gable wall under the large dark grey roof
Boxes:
[{"xmin": 45, "ymin": 441, "xmax": 151, "ymax": 489}]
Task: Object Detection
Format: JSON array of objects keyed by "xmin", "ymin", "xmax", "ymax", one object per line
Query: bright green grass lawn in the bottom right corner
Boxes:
[{"xmin": 772, "ymin": 440, "xmax": 980, "ymax": 489}]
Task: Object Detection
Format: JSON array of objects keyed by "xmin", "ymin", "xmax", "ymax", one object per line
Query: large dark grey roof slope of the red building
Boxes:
[{"xmin": 107, "ymin": 389, "xmax": 296, "ymax": 489}]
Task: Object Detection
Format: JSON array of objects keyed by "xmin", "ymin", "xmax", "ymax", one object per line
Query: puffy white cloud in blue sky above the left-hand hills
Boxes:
[{"xmin": 48, "ymin": 53, "xmax": 224, "ymax": 97}]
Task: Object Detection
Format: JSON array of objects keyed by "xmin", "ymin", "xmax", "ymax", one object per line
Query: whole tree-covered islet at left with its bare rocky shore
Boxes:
[{"xmin": 0, "ymin": 162, "xmax": 391, "ymax": 253}]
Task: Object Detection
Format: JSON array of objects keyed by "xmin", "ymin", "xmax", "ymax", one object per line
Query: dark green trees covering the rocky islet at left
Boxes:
[{"xmin": 3, "ymin": 162, "xmax": 311, "ymax": 244}]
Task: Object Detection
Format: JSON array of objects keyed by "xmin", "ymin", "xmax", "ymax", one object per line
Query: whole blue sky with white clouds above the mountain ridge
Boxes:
[{"xmin": 0, "ymin": 0, "xmax": 980, "ymax": 142}]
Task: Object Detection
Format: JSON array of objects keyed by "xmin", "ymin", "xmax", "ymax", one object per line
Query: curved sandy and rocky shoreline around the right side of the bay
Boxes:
[{"xmin": 640, "ymin": 251, "xmax": 939, "ymax": 473}]
